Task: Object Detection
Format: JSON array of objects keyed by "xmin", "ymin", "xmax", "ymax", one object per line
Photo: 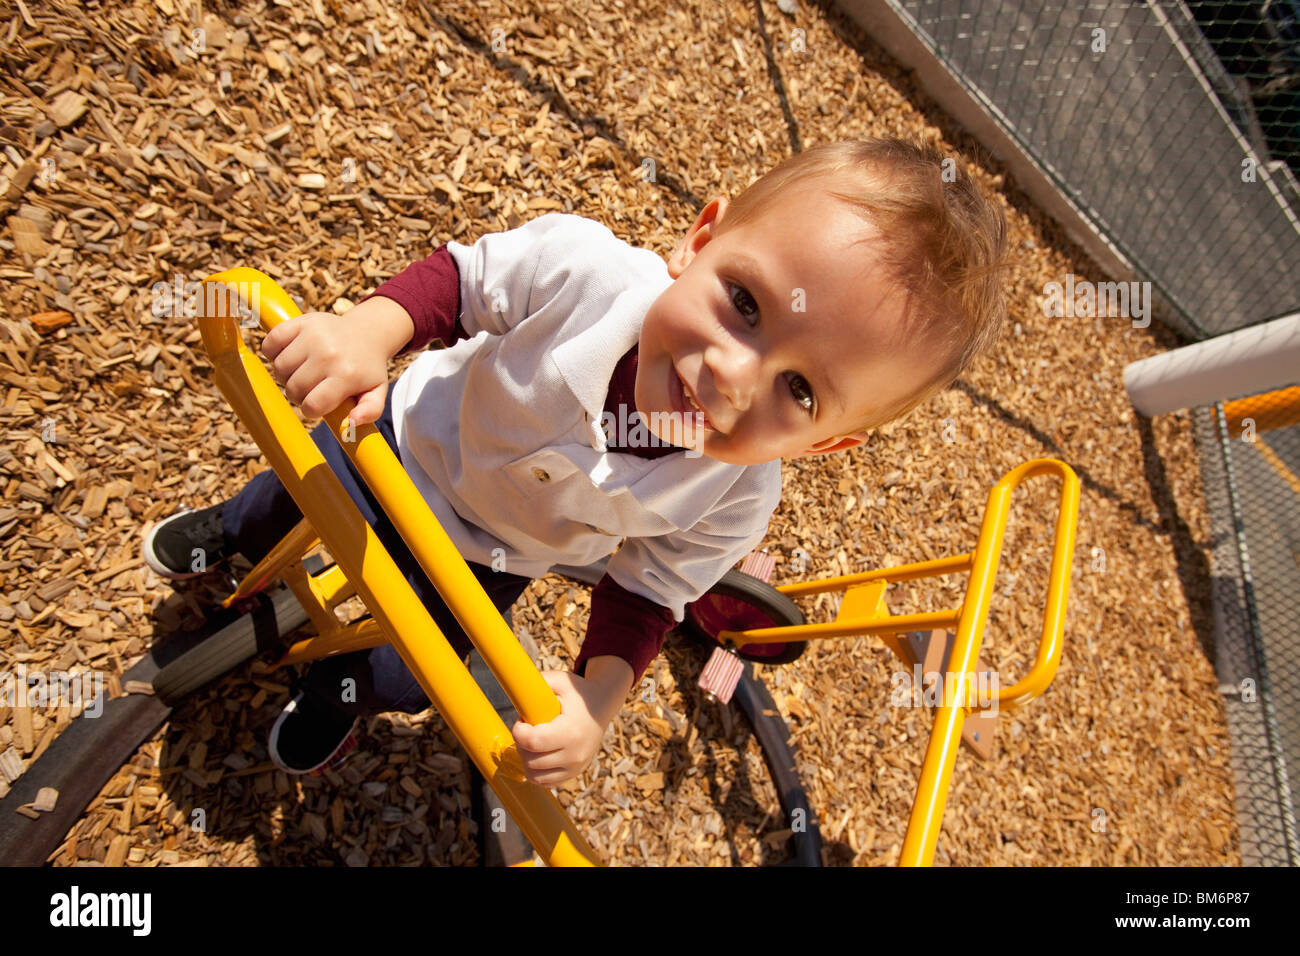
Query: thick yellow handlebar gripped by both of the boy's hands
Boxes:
[{"xmin": 199, "ymin": 269, "xmax": 595, "ymax": 865}]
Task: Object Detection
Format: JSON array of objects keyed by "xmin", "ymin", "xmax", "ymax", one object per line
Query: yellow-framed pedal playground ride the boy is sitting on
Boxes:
[{"xmin": 0, "ymin": 268, "xmax": 1079, "ymax": 865}]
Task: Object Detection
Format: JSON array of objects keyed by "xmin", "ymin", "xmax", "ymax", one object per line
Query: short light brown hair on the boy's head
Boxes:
[{"xmin": 718, "ymin": 138, "xmax": 1006, "ymax": 431}]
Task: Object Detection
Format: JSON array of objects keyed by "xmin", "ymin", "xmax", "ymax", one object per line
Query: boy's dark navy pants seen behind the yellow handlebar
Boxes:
[{"xmin": 221, "ymin": 386, "xmax": 532, "ymax": 715}]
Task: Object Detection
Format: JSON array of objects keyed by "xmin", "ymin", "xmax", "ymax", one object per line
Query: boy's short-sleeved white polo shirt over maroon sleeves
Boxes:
[{"xmin": 379, "ymin": 213, "xmax": 781, "ymax": 620}]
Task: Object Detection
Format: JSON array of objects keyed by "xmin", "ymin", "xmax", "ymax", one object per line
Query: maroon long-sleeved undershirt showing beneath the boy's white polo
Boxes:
[{"xmin": 361, "ymin": 246, "xmax": 683, "ymax": 687}]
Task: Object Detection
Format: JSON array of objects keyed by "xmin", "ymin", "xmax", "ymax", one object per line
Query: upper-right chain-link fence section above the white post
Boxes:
[{"xmin": 888, "ymin": 0, "xmax": 1300, "ymax": 339}]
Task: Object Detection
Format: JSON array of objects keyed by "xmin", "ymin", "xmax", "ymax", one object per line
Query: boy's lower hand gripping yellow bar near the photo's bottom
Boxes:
[{"xmin": 510, "ymin": 671, "xmax": 618, "ymax": 787}]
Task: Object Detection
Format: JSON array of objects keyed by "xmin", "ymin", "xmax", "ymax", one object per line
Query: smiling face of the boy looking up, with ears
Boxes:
[{"xmin": 636, "ymin": 185, "xmax": 943, "ymax": 464}]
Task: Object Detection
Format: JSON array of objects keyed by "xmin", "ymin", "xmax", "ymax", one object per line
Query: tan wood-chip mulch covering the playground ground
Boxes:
[{"xmin": 0, "ymin": 0, "xmax": 1240, "ymax": 866}]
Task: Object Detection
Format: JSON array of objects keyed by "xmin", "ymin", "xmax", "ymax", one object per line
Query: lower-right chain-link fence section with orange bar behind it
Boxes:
[{"xmin": 1196, "ymin": 388, "xmax": 1300, "ymax": 865}]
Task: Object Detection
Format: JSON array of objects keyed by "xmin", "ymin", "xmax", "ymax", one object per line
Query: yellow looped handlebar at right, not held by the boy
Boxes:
[{"xmin": 900, "ymin": 458, "xmax": 1079, "ymax": 866}]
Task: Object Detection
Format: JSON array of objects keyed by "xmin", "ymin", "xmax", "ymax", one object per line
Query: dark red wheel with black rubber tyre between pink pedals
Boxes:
[{"xmin": 683, "ymin": 570, "xmax": 807, "ymax": 663}]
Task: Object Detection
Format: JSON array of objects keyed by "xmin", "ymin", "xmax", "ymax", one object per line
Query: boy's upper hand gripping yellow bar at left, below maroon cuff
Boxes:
[{"xmin": 261, "ymin": 310, "xmax": 393, "ymax": 425}]
